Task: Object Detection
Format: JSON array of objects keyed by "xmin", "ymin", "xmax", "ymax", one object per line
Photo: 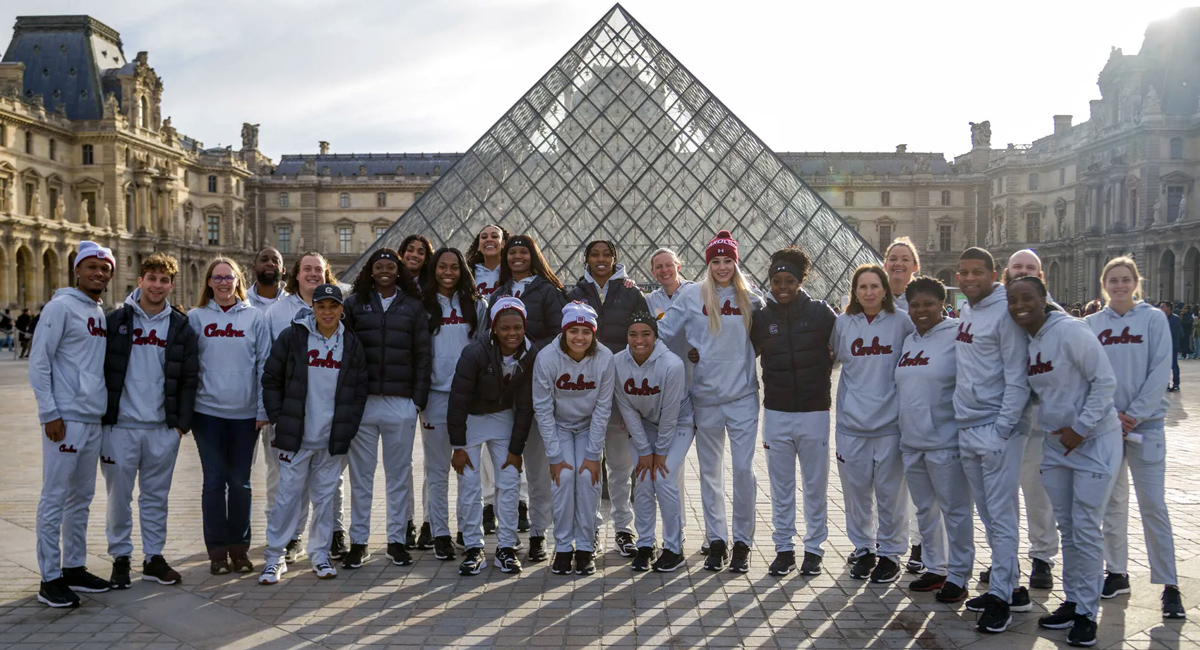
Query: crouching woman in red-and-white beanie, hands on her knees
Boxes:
[{"xmin": 533, "ymin": 302, "xmax": 613, "ymax": 576}]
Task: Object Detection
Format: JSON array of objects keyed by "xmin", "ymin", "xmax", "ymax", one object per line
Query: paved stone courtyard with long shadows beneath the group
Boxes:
[{"xmin": 0, "ymin": 354, "xmax": 1200, "ymax": 650}]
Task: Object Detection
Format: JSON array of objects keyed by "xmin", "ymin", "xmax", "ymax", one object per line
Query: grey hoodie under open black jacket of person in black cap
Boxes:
[{"xmin": 293, "ymin": 311, "xmax": 346, "ymax": 450}]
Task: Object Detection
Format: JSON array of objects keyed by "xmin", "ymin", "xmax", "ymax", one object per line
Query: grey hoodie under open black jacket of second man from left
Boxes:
[{"xmin": 114, "ymin": 289, "xmax": 170, "ymax": 428}]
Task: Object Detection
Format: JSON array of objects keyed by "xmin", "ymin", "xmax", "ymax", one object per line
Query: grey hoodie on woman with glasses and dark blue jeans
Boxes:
[{"xmin": 187, "ymin": 300, "xmax": 270, "ymax": 421}]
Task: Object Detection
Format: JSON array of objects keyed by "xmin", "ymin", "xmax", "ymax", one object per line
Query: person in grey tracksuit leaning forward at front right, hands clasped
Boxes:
[{"xmin": 1008, "ymin": 276, "xmax": 1121, "ymax": 646}]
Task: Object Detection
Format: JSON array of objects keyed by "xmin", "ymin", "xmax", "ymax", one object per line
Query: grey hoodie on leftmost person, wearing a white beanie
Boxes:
[{"xmin": 29, "ymin": 287, "xmax": 108, "ymax": 425}]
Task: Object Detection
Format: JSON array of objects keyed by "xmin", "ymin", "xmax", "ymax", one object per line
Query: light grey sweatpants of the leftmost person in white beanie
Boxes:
[{"xmin": 37, "ymin": 421, "xmax": 103, "ymax": 582}]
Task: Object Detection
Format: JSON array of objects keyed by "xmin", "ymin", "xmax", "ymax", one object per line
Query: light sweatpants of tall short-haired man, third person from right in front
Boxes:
[{"xmin": 959, "ymin": 425, "xmax": 1026, "ymax": 602}]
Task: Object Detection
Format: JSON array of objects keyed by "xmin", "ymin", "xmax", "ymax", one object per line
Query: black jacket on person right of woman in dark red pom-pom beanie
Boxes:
[{"xmin": 750, "ymin": 289, "xmax": 836, "ymax": 413}]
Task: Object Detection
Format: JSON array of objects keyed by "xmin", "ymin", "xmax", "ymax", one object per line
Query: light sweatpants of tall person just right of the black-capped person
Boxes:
[{"xmin": 349, "ymin": 395, "xmax": 416, "ymax": 544}]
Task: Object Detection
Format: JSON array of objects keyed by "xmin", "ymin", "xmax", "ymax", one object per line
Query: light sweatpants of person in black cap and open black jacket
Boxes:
[{"xmin": 263, "ymin": 449, "xmax": 347, "ymax": 566}]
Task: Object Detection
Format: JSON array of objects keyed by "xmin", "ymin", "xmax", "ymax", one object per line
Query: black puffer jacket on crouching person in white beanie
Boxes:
[{"xmin": 446, "ymin": 338, "xmax": 541, "ymax": 456}]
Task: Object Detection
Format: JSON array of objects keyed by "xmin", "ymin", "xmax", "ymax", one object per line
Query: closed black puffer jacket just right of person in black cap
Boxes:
[{"xmin": 344, "ymin": 291, "xmax": 433, "ymax": 410}]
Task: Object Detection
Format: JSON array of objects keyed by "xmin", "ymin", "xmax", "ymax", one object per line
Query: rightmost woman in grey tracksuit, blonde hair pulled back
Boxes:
[{"xmin": 1085, "ymin": 257, "xmax": 1187, "ymax": 619}]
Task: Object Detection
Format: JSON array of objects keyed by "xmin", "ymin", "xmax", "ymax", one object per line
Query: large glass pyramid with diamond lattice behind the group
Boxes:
[{"xmin": 342, "ymin": 5, "xmax": 878, "ymax": 300}]
